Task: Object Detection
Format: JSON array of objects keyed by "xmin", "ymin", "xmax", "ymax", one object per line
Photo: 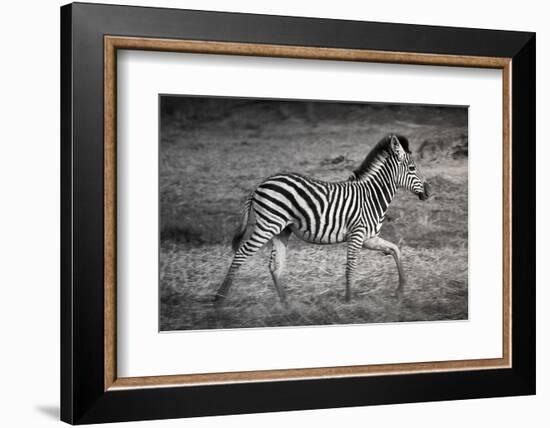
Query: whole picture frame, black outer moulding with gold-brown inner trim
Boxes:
[{"xmin": 61, "ymin": 3, "xmax": 536, "ymax": 424}]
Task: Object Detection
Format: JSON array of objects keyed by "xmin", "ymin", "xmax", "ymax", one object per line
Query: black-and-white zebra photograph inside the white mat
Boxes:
[{"xmin": 159, "ymin": 94, "xmax": 468, "ymax": 331}]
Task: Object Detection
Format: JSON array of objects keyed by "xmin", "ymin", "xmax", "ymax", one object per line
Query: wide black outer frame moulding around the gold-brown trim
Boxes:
[{"xmin": 61, "ymin": 3, "xmax": 535, "ymax": 424}]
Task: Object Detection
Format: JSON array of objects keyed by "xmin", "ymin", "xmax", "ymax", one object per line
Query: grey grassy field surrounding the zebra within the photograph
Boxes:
[{"xmin": 160, "ymin": 99, "xmax": 468, "ymax": 331}]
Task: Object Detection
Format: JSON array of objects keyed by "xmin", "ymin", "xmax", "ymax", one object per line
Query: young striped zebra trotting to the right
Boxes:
[{"xmin": 214, "ymin": 134, "xmax": 430, "ymax": 304}]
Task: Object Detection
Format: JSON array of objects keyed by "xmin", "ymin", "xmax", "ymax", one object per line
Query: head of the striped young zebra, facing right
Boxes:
[{"xmin": 388, "ymin": 134, "xmax": 430, "ymax": 201}]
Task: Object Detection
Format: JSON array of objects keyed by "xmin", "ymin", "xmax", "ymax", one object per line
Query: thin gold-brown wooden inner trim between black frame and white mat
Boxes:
[{"xmin": 104, "ymin": 36, "xmax": 512, "ymax": 391}]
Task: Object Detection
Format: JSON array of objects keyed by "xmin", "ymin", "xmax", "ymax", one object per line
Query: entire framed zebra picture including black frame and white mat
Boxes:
[{"xmin": 61, "ymin": 3, "xmax": 535, "ymax": 424}]
